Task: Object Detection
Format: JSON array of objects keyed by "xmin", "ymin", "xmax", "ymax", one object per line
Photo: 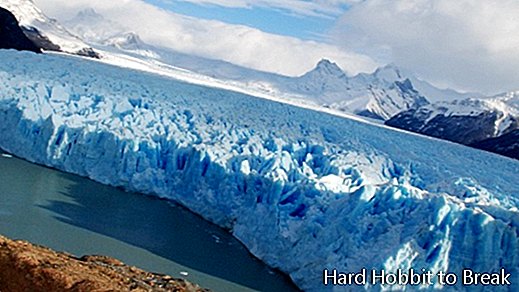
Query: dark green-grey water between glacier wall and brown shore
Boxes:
[{"xmin": 0, "ymin": 155, "xmax": 296, "ymax": 291}]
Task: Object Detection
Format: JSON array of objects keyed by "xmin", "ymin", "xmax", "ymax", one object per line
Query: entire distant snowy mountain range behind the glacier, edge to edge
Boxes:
[{"xmin": 0, "ymin": 0, "xmax": 519, "ymax": 158}]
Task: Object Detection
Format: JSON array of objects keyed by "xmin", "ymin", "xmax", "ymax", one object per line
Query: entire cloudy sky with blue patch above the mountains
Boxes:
[{"xmin": 34, "ymin": 0, "xmax": 519, "ymax": 95}]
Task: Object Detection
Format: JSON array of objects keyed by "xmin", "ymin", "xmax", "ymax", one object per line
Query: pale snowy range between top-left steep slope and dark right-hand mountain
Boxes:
[{"xmin": 65, "ymin": 9, "xmax": 476, "ymax": 120}]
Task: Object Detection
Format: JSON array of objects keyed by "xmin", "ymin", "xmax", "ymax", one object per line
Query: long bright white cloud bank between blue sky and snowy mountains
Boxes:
[{"xmin": 35, "ymin": 0, "xmax": 376, "ymax": 76}]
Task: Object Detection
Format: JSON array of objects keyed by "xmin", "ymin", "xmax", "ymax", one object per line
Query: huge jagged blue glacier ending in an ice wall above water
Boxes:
[{"xmin": 0, "ymin": 51, "xmax": 519, "ymax": 291}]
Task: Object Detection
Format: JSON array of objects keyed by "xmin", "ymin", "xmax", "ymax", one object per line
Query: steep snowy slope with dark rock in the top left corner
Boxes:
[{"xmin": 0, "ymin": 0, "xmax": 99, "ymax": 57}]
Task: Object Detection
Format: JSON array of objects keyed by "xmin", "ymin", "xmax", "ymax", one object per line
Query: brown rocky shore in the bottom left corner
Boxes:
[{"xmin": 0, "ymin": 236, "xmax": 208, "ymax": 292}]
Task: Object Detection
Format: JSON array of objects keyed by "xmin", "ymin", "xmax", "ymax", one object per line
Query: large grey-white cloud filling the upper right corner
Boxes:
[{"xmin": 334, "ymin": 0, "xmax": 519, "ymax": 93}]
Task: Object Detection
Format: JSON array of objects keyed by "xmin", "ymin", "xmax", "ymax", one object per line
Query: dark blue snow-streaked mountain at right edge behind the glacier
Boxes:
[{"xmin": 386, "ymin": 92, "xmax": 519, "ymax": 155}]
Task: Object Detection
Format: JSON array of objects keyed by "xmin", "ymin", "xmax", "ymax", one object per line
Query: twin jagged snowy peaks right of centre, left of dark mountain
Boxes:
[{"xmin": 288, "ymin": 60, "xmax": 428, "ymax": 120}]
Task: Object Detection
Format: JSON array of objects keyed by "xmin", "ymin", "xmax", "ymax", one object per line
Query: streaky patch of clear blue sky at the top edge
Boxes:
[{"xmin": 145, "ymin": 0, "xmax": 347, "ymax": 41}]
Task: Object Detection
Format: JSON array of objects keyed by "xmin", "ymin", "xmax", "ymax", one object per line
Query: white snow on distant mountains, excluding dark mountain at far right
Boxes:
[{"xmin": 0, "ymin": 0, "xmax": 480, "ymax": 120}]
